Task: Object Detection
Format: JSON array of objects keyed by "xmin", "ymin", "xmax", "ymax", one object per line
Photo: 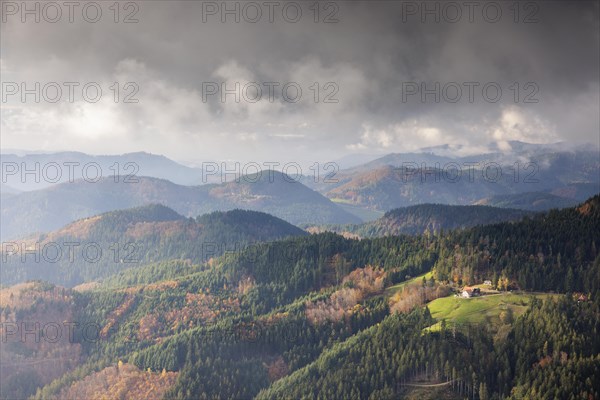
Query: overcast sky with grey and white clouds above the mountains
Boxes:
[{"xmin": 0, "ymin": 1, "xmax": 600, "ymax": 164}]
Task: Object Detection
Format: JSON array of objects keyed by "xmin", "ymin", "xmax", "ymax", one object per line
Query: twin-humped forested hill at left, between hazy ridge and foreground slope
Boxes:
[{"xmin": 1, "ymin": 205, "xmax": 307, "ymax": 286}]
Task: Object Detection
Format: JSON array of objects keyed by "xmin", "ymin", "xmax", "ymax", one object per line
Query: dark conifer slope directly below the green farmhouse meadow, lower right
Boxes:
[{"xmin": 258, "ymin": 299, "xmax": 600, "ymax": 400}]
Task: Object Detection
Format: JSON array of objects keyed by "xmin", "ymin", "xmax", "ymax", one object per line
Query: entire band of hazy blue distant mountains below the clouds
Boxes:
[{"xmin": 0, "ymin": 141, "xmax": 600, "ymax": 239}]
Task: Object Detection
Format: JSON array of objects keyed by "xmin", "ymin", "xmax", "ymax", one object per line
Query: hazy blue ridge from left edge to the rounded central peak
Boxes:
[{"xmin": 1, "ymin": 171, "xmax": 361, "ymax": 240}]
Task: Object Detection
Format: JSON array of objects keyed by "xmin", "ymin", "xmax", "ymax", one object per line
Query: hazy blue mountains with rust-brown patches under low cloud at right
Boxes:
[{"xmin": 314, "ymin": 150, "xmax": 600, "ymax": 212}]
